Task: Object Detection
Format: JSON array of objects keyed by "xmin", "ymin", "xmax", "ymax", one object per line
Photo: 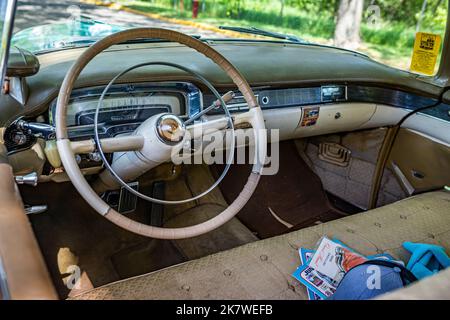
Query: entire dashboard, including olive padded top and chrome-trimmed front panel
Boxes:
[{"xmin": 0, "ymin": 41, "xmax": 450, "ymax": 179}]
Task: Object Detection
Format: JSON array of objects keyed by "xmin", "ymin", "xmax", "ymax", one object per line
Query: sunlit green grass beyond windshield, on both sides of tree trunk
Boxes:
[{"xmin": 116, "ymin": 0, "xmax": 442, "ymax": 69}]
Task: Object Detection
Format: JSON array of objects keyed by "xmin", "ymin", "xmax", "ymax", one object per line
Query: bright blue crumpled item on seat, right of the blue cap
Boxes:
[{"xmin": 403, "ymin": 242, "xmax": 450, "ymax": 279}]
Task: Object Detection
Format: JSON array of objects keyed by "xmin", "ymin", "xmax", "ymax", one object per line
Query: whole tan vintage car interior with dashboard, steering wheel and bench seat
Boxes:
[{"xmin": 0, "ymin": 2, "xmax": 450, "ymax": 300}]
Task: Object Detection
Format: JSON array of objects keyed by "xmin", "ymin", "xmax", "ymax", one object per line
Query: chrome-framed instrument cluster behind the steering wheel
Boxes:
[{"xmin": 49, "ymin": 82, "xmax": 202, "ymax": 139}]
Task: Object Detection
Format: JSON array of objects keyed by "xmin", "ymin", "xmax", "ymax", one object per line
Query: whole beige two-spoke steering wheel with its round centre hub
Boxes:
[{"xmin": 55, "ymin": 28, "xmax": 267, "ymax": 240}]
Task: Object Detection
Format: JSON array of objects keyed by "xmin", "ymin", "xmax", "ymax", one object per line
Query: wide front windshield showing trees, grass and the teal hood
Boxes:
[{"xmin": 13, "ymin": 0, "xmax": 449, "ymax": 75}]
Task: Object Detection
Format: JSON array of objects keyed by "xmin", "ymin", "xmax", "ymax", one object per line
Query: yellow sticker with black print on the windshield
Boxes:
[{"xmin": 410, "ymin": 32, "xmax": 441, "ymax": 76}]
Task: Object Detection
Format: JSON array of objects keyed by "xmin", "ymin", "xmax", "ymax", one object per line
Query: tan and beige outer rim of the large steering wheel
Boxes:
[{"xmin": 55, "ymin": 28, "xmax": 267, "ymax": 240}]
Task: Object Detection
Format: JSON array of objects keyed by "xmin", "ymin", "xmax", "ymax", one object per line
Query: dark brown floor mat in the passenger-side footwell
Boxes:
[{"xmin": 215, "ymin": 141, "xmax": 343, "ymax": 238}]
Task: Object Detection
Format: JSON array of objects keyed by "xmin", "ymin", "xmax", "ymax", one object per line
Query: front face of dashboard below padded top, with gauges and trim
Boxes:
[{"xmin": 4, "ymin": 81, "xmax": 448, "ymax": 154}]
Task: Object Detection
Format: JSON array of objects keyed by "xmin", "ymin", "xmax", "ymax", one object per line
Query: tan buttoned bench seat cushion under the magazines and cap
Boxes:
[{"xmin": 75, "ymin": 191, "xmax": 450, "ymax": 299}]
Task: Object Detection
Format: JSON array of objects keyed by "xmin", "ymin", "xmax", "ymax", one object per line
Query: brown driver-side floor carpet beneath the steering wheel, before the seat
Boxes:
[{"xmin": 21, "ymin": 165, "xmax": 258, "ymax": 298}]
